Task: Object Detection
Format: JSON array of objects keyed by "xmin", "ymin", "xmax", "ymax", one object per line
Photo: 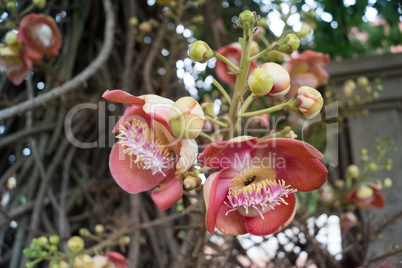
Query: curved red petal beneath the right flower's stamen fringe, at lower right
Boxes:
[{"xmin": 244, "ymin": 194, "xmax": 296, "ymax": 235}]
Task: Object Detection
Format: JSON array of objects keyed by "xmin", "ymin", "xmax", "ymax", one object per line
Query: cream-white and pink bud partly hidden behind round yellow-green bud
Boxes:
[{"xmin": 260, "ymin": 62, "xmax": 290, "ymax": 98}]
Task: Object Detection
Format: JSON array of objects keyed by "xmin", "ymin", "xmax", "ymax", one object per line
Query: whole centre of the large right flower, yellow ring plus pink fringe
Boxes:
[{"xmin": 224, "ymin": 168, "xmax": 297, "ymax": 219}]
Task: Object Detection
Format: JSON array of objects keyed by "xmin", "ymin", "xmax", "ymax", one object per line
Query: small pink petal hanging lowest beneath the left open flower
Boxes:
[{"xmin": 151, "ymin": 172, "xmax": 183, "ymax": 211}]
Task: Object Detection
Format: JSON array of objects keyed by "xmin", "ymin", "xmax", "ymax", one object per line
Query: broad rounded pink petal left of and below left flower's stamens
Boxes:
[{"xmin": 109, "ymin": 143, "xmax": 165, "ymax": 194}]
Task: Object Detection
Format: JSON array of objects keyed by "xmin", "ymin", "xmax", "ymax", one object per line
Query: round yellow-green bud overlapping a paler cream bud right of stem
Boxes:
[{"xmin": 247, "ymin": 68, "xmax": 274, "ymax": 96}]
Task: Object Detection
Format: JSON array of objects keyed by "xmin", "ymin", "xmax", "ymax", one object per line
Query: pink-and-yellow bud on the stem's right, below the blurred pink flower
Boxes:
[{"xmin": 286, "ymin": 86, "xmax": 324, "ymax": 119}]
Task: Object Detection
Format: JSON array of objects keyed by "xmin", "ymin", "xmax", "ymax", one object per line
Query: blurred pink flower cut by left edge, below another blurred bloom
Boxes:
[{"xmin": 0, "ymin": 44, "xmax": 32, "ymax": 85}]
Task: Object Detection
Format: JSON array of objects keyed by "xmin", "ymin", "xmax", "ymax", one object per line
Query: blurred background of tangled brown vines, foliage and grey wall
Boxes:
[{"xmin": 0, "ymin": 0, "xmax": 402, "ymax": 268}]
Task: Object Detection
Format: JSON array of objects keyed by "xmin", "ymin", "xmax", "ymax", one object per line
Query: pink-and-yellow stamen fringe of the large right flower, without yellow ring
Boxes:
[{"xmin": 224, "ymin": 180, "xmax": 297, "ymax": 219}]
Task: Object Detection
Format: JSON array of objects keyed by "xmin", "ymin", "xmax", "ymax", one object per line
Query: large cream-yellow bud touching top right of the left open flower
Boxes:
[{"xmin": 168, "ymin": 97, "xmax": 205, "ymax": 139}]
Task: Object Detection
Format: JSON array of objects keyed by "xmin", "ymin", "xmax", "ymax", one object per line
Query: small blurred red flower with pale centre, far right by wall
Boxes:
[{"xmin": 348, "ymin": 184, "xmax": 385, "ymax": 209}]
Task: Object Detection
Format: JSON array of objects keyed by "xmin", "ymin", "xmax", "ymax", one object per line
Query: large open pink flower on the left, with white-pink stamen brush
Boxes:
[{"xmin": 103, "ymin": 90, "xmax": 198, "ymax": 211}]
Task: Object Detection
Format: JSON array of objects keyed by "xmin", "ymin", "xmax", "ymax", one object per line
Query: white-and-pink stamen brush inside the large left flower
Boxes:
[{"xmin": 117, "ymin": 119, "xmax": 174, "ymax": 176}]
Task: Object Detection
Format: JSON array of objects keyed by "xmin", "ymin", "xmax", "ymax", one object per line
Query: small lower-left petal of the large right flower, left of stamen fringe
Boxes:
[{"xmin": 216, "ymin": 199, "xmax": 248, "ymax": 235}]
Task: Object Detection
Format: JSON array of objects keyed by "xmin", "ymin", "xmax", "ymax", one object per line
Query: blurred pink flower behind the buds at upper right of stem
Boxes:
[{"xmin": 286, "ymin": 50, "xmax": 329, "ymax": 96}]
